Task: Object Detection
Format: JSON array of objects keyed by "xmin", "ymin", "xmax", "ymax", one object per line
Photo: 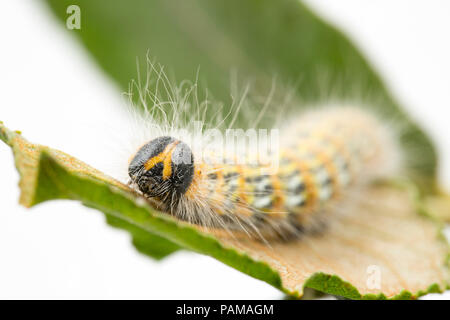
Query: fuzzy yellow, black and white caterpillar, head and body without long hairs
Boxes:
[{"xmin": 128, "ymin": 108, "xmax": 399, "ymax": 239}]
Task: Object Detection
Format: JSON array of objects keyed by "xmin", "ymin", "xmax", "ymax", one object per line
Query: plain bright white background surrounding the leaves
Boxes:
[{"xmin": 0, "ymin": 0, "xmax": 450, "ymax": 299}]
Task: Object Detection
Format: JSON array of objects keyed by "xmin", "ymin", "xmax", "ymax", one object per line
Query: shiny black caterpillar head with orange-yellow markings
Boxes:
[{"xmin": 128, "ymin": 136, "xmax": 194, "ymax": 199}]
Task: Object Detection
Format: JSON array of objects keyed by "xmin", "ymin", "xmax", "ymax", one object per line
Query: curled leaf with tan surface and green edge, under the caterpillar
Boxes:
[{"xmin": 0, "ymin": 123, "xmax": 449, "ymax": 299}]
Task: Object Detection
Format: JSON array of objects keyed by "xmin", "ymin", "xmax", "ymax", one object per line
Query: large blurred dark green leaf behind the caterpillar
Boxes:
[{"xmin": 42, "ymin": 0, "xmax": 436, "ymax": 191}]
